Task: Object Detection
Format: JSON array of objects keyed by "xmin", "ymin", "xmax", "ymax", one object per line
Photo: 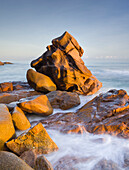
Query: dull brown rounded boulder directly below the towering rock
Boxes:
[{"xmin": 46, "ymin": 90, "xmax": 80, "ymax": 110}]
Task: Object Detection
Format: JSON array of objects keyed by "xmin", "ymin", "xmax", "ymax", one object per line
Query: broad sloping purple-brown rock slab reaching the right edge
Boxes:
[{"xmin": 42, "ymin": 89, "xmax": 129, "ymax": 138}]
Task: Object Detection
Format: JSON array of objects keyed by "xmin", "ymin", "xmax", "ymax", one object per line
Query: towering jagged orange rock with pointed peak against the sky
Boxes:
[{"xmin": 31, "ymin": 32, "xmax": 102, "ymax": 95}]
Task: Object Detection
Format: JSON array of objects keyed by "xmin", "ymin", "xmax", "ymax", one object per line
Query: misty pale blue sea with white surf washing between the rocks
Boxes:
[{"xmin": 0, "ymin": 58, "xmax": 129, "ymax": 170}]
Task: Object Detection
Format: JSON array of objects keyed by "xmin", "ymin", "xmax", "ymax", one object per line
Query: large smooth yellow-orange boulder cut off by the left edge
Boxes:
[{"xmin": 0, "ymin": 104, "xmax": 15, "ymax": 150}]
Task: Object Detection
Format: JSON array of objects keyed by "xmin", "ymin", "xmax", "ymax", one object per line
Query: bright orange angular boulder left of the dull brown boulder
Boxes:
[{"xmin": 18, "ymin": 95, "xmax": 53, "ymax": 116}]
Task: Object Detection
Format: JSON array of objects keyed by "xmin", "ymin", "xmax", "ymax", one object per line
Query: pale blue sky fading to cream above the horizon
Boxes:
[{"xmin": 0, "ymin": 0, "xmax": 129, "ymax": 61}]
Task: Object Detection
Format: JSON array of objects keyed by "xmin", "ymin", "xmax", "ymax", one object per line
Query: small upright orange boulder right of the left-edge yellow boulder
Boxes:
[{"xmin": 12, "ymin": 106, "xmax": 31, "ymax": 130}]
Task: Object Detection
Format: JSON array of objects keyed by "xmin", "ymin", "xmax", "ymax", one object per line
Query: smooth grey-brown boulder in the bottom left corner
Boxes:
[{"xmin": 0, "ymin": 151, "xmax": 32, "ymax": 170}]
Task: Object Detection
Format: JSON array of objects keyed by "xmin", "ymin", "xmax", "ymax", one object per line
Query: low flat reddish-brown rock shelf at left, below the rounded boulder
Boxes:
[{"xmin": 0, "ymin": 90, "xmax": 41, "ymax": 104}]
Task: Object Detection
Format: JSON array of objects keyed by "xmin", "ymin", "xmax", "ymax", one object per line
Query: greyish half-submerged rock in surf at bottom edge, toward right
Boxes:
[{"xmin": 92, "ymin": 159, "xmax": 121, "ymax": 170}]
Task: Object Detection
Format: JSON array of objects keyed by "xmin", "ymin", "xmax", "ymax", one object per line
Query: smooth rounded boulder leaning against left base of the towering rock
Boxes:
[{"xmin": 27, "ymin": 69, "xmax": 56, "ymax": 93}]
